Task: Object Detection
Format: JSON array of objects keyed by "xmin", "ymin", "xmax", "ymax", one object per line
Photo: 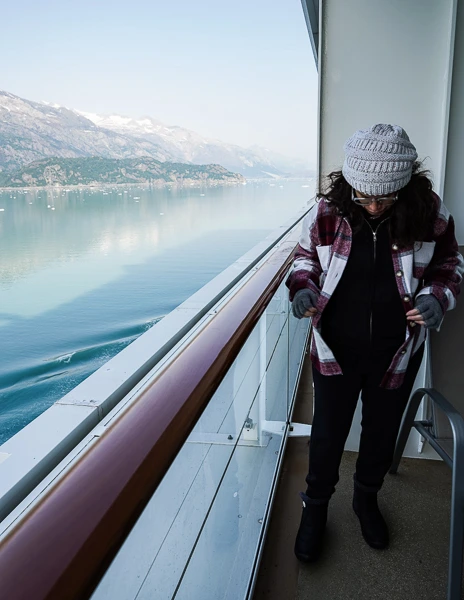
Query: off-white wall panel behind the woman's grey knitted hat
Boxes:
[{"xmin": 319, "ymin": 0, "xmax": 454, "ymax": 193}]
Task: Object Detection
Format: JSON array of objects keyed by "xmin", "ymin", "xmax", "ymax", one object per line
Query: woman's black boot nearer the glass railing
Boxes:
[{"xmin": 295, "ymin": 493, "xmax": 329, "ymax": 562}]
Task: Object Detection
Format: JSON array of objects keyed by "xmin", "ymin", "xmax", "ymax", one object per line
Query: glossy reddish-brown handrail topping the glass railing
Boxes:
[{"xmin": 0, "ymin": 236, "xmax": 295, "ymax": 600}]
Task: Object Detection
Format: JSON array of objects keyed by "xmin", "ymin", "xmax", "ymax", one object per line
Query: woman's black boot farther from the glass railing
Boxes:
[{"xmin": 353, "ymin": 479, "xmax": 389, "ymax": 550}]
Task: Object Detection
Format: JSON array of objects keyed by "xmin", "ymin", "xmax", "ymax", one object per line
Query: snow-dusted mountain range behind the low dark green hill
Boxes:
[{"xmin": 0, "ymin": 91, "xmax": 311, "ymax": 177}]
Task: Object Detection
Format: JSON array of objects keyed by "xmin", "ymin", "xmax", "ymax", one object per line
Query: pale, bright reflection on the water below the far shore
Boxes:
[{"xmin": 0, "ymin": 182, "xmax": 309, "ymax": 316}]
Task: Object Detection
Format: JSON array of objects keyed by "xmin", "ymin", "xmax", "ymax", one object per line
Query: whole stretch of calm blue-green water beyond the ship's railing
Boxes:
[{"xmin": 0, "ymin": 181, "xmax": 313, "ymax": 443}]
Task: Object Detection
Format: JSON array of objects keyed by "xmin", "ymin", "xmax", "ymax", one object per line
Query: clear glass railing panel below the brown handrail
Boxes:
[{"xmin": 92, "ymin": 272, "xmax": 307, "ymax": 600}]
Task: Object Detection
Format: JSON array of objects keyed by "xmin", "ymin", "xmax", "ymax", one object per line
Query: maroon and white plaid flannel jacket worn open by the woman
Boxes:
[{"xmin": 285, "ymin": 196, "xmax": 464, "ymax": 389}]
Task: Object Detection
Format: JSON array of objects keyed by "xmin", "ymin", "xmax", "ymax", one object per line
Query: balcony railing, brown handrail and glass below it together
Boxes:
[{"xmin": 0, "ymin": 207, "xmax": 316, "ymax": 600}]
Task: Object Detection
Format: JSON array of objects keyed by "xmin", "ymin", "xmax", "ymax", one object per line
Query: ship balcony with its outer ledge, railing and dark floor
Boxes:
[{"xmin": 0, "ymin": 207, "xmax": 464, "ymax": 600}]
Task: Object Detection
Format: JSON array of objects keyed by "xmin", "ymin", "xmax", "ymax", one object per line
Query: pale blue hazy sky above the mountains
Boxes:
[{"xmin": 0, "ymin": 0, "xmax": 317, "ymax": 162}]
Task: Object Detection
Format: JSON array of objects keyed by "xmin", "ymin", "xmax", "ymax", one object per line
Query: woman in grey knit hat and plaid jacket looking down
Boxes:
[{"xmin": 286, "ymin": 124, "xmax": 463, "ymax": 562}]
